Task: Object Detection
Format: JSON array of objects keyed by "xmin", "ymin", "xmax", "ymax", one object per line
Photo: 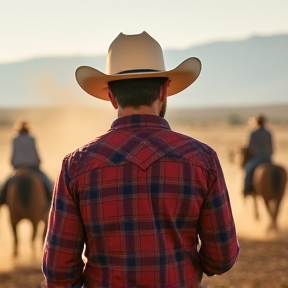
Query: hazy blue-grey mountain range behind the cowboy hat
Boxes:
[{"xmin": 0, "ymin": 34, "xmax": 288, "ymax": 108}]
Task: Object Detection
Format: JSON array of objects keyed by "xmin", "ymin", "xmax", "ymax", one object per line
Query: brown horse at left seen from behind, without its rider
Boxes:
[{"xmin": 6, "ymin": 169, "xmax": 49, "ymax": 256}]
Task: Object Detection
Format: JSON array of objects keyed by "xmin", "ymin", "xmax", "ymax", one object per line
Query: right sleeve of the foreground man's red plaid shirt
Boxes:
[{"xmin": 199, "ymin": 152, "xmax": 239, "ymax": 276}]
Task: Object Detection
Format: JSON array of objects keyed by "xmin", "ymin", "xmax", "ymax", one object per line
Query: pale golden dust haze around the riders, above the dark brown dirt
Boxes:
[{"xmin": 0, "ymin": 107, "xmax": 288, "ymax": 271}]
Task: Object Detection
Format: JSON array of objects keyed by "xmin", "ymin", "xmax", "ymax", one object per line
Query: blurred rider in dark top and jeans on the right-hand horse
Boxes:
[{"xmin": 243, "ymin": 115, "xmax": 273, "ymax": 196}]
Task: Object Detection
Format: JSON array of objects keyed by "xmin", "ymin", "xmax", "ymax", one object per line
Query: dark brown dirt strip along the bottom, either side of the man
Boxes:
[{"xmin": 0, "ymin": 239, "xmax": 288, "ymax": 288}]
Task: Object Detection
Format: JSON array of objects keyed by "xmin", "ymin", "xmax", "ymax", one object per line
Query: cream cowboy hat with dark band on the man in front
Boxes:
[{"xmin": 76, "ymin": 32, "xmax": 201, "ymax": 101}]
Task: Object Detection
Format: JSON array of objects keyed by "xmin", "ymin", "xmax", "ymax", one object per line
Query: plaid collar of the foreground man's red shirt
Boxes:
[{"xmin": 110, "ymin": 114, "xmax": 171, "ymax": 130}]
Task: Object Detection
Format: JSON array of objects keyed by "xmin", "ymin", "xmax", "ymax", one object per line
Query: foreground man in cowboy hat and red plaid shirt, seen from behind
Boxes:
[{"xmin": 43, "ymin": 32, "xmax": 239, "ymax": 288}]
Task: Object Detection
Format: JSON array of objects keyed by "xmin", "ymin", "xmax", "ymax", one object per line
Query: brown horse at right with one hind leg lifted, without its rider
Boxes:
[{"xmin": 241, "ymin": 147, "xmax": 287, "ymax": 230}]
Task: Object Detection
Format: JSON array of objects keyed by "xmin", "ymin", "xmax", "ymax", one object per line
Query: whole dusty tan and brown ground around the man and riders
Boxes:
[{"xmin": 0, "ymin": 108, "xmax": 288, "ymax": 288}]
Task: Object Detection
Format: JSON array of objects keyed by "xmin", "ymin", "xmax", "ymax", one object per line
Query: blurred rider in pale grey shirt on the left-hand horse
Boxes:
[{"xmin": 0, "ymin": 122, "xmax": 53, "ymax": 205}]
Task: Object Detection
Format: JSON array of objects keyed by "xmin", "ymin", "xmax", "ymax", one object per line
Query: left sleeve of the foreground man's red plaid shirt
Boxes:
[{"xmin": 42, "ymin": 158, "xmax": 85, "ymax": 288}]
